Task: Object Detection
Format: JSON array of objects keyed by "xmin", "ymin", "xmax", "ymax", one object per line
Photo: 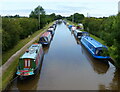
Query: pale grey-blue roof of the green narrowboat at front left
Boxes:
[{"xmin": 20, "ymin": 43, "xmax": 42, "ymax": 59}]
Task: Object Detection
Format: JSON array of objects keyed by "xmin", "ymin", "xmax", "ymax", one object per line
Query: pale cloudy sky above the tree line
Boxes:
[{"xmin": 0, "ymin": 0, "xmax": 120, "ymax": 17}]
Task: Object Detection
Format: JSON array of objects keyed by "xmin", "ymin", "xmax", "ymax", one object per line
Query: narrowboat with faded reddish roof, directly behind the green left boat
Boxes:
[{"xmin": 38, "ymin": 32, "xmax": 52, "ymax": 45}]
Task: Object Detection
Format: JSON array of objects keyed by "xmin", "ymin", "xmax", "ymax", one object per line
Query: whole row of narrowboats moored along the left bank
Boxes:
[{"xmin": 16, "ymin": 22, "xmax": 57, "ymax": 78}]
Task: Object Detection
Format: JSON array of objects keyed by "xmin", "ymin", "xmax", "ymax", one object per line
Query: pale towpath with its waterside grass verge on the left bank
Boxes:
[{"xmin": 0, "ymin": 23, "xmax": 53, "ymax": 90}]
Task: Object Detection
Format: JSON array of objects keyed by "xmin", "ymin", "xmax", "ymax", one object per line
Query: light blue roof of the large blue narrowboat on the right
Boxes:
[{"xmin": 83, "ymin": 36, "xmax": 105, "ymax": 48}]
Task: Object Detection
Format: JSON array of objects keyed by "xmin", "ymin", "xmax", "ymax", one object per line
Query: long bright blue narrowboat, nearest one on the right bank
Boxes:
[{"xmin": 81, "ymin": 36, "xmax": 110, "ymax": 59}]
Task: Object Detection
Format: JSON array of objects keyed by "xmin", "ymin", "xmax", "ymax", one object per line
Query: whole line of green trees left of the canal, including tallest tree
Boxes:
[{"xmin": 2, "ymin": 6, "xmax": 62, "ymax": 53}]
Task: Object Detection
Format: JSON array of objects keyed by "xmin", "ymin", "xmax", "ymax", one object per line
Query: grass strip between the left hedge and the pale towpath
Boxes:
[{"xmin": 2, "ymin": 23, "xmax": 51, "ymax": 65}]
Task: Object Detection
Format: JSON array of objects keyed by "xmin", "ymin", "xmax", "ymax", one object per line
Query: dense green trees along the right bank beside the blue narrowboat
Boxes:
[{"xmin": 82, "ymin": 14, "xmax": 120, "ymax": 67}]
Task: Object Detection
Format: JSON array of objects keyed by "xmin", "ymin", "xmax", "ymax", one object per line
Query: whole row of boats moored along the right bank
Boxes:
[{"xmin": 66, "ymin": 20, "xmax": 110, "ymax": 59}]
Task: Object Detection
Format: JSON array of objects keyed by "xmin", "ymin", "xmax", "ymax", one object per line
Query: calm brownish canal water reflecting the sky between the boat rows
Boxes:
[{"xmin": 9, "ymin": 23, "xmax": 120, "ymax": 91}]
